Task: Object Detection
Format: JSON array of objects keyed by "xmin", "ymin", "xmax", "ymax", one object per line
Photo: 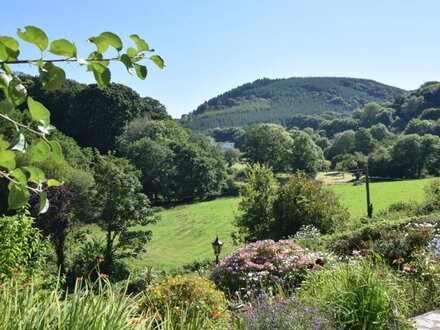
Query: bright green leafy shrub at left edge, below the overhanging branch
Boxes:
[{"xmin": 0, "ymin": 212, "xmax": 48, "ymax": 281}]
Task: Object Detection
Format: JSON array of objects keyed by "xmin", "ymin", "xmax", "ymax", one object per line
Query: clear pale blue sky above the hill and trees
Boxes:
[{"xmin": 0, "ymin": 0, "xmax": 440, "ymax": 118}]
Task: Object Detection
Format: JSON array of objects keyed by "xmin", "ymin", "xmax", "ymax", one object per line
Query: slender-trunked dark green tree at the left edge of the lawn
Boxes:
[{"xmin": 94, "ymin": 154, "xmax": 156, "ymax": 273}]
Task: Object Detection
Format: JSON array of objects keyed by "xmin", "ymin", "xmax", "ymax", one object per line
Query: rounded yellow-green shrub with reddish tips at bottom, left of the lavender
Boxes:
[{"xmin": 142, "ymin": 275, "xmax": 229, "ymax": 324}]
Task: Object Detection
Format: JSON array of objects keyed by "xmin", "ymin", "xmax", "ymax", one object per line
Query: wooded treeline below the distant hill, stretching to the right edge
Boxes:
[{"xmin": 206, "ymin": 82, "xmax": 440, "ymax": 178}]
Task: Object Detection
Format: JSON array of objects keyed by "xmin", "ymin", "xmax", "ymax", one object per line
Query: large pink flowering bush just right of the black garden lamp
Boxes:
[{"xmin": 213, "ymin": 240, "xmax": 324, "ymax": 295}]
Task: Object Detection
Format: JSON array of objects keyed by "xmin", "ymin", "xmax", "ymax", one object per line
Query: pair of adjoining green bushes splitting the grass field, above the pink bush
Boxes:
[{"xmin": 235, "ymin": 165, "xmax": 349, "ymax": 242}]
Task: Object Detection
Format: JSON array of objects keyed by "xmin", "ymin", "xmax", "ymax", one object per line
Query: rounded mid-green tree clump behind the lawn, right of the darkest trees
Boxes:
[{"xmin": 118, "ymin": 119, "xmax": 226, "ymax": 202}]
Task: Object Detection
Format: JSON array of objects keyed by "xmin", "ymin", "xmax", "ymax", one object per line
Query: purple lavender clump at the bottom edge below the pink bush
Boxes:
[{"xmin": 236, "ymin": 294, "xmax": 331, "ymax": 330}]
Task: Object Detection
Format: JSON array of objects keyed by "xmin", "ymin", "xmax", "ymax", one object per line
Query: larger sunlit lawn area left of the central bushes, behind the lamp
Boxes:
[{"xmin": 128, "ymin": 198, "xmax": 238, "ymax": 270}]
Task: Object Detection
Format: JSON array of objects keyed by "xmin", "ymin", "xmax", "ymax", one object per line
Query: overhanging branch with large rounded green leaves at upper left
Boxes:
[{"xmin": 0, "ymin": 26, "xmax": 164, "ymax": 213}]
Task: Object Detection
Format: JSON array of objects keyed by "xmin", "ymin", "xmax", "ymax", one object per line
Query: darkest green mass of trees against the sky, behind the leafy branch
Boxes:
[{"xmin": 21, "ymin": 76, "xmax": 169, "ymax": 152}]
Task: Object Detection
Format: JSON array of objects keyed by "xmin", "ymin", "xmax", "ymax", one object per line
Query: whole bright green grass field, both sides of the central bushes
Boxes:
[{"xmin": 93, "ymin": 179, "xmax": 436, "ymax": 270}]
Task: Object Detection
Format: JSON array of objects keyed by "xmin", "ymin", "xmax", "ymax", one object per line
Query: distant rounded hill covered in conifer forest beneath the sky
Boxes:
[{"xmin": 182, "ymin": 77, "xmax": 405, "ymax": 130}]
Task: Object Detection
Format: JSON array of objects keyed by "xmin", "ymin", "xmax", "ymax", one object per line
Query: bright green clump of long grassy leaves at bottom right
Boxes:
[{"xmin": 302, "ymin": 258, "xmax": 408, "ymax": 329}]
